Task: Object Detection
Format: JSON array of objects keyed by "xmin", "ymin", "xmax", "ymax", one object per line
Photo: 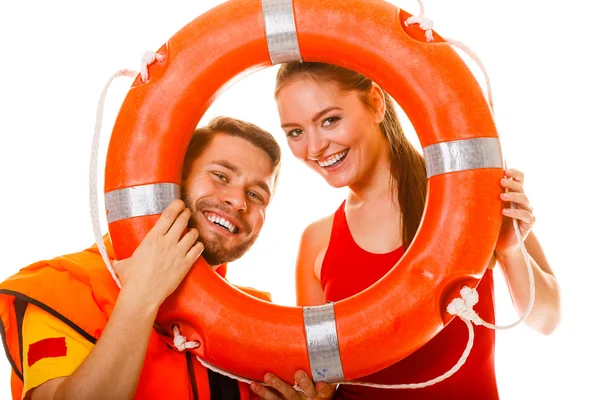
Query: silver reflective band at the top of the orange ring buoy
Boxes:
[{"xmin": 262, "ymin": 0, "xmax": 302, "ymax": 65}]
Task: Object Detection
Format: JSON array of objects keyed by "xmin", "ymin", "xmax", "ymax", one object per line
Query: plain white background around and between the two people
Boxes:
[{"xmin": 0, "ymin": 0, "xmax": 600, "ymax": 399}]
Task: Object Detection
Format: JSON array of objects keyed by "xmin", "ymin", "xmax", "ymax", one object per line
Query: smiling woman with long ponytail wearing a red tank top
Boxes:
[{"xmin": 252, "ymin": 62, "xmax": 560, "ymax": 400}]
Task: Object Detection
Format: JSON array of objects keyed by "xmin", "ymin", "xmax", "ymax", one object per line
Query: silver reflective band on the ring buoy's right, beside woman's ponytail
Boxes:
[{"xmin": 423, "ymin": 138, "xmax": 504, "ymax": 178}]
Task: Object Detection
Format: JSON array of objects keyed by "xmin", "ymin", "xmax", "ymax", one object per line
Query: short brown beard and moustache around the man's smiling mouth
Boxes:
[{"xmin": 183, "ymin": 194, "xmax": 258, "ymax": 266}]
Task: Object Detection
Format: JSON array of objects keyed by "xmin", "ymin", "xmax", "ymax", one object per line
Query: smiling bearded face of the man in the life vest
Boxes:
[{"xmin": 183, "ymin": 133, "xmax": 275, "ymax": 266}]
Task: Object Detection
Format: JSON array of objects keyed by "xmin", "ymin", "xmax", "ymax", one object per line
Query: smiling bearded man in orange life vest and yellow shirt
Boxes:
[{"xmin": 0, "ymin": 117, "xmax": 281, "ymax": 400}]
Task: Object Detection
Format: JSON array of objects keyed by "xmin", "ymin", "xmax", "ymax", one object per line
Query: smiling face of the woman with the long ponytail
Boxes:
[{"xmin": 277, "ymin": 78, "xmax": 388, "ymax": 187}]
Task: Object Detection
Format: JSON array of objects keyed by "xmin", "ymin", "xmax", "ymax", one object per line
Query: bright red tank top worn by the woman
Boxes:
[{"xmin": 321, "ymin": 202, "xmax": 499, "ymax": 400}]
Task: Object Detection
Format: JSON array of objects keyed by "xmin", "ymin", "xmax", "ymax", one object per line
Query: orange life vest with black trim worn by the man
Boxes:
[{"xmin": 0, "ymin": 239, "xmax": 262, "ymax": 400}]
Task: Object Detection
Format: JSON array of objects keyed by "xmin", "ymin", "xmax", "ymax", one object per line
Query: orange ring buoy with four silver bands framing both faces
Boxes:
[{"xmin": 105, "ymin": 0, "xmax": 503, "ymax": 383}]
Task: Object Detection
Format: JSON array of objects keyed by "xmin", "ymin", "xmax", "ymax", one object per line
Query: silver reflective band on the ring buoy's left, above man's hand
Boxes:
[{"xmin": 104, "ymin": 183, "xmax": 180, "ymax": 223}]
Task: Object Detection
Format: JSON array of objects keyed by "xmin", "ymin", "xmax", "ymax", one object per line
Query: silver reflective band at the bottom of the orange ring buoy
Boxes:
[{"xmin": 304, "ymin": 303, "xmax": 344, "ymax": 382}]
